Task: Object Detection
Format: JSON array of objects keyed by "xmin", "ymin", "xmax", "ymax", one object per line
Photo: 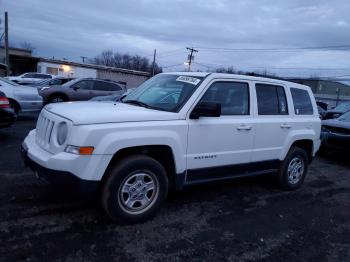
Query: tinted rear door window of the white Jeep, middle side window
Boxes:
[{"xmin": 255, "ymin": 84, "xmax": 288, "ymax": 115}]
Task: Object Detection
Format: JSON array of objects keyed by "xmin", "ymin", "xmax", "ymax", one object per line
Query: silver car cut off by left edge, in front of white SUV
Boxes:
[{"xmin": 0, "ymin": 77, "xmax": 43, "ymax": 114}]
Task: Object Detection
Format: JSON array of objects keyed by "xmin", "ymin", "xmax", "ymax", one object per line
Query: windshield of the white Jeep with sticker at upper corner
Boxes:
[{"xmin": 122, "ymin": 74, "xmax": 203, "ymax": 112}]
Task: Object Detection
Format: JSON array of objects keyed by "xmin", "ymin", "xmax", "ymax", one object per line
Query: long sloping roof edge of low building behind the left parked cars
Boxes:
[{"xmin": 37, "ymin": 57, "xmax": 150, "ymax": 77}]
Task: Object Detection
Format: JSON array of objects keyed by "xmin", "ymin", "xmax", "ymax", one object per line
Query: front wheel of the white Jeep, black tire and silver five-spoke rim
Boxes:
[{"xmin": 101, "ymin": 155, "xmax": 169, "ymax": 224}]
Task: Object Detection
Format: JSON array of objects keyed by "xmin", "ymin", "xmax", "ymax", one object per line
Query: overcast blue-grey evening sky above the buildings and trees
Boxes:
[{"xmin": 0, "ymin": 0, "xmax": 350, "ymax": 76}]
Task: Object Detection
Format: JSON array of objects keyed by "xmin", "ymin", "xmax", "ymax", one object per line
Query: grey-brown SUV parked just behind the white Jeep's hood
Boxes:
[{"xmin": 39, "ymin": 78, "xmax": 126, "ymax": 103}]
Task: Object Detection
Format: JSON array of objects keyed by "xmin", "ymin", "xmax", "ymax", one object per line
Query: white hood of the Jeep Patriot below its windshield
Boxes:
[{"xmin": 45, "ymin": 101, "xmax": 179, "ymax": 125}]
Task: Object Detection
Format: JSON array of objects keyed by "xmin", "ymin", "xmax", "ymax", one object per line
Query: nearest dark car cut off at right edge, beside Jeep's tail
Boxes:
[{"xmin": 321, "ymin": 111, "xmax": 350, "ymax": 150}]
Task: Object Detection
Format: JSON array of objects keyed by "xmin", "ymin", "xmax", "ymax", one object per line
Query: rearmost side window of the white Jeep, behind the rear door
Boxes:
[{"xmin": 290, "ymin": 88, "xmax": 314, "ymax": 115}]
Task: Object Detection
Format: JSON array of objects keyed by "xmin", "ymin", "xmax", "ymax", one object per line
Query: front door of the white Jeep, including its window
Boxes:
[{"xmin": 187, "ymin": 81, "xmax": 255, "ymax": 182}]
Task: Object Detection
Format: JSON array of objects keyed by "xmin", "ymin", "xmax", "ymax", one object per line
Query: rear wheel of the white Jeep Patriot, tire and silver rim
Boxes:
[{"xmin": 278, "ymin": 147, "xmax": 308, "ymax": 190}]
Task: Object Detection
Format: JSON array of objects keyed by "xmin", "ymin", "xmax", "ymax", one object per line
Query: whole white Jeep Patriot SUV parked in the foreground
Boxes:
[{"xmin": 22, "ymin": 72, "xmax": 321, "ymax": 223}]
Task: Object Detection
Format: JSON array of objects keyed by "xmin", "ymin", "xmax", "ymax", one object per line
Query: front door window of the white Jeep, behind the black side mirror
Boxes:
[{"xmin": 201, "ymin": 82, "xmax": 249, "ymax": 115}]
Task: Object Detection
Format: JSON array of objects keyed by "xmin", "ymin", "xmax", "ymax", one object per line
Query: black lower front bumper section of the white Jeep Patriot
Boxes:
[{"xmin": 21, "ymin": 144, "xmax": 99, "ymax": 196}]
